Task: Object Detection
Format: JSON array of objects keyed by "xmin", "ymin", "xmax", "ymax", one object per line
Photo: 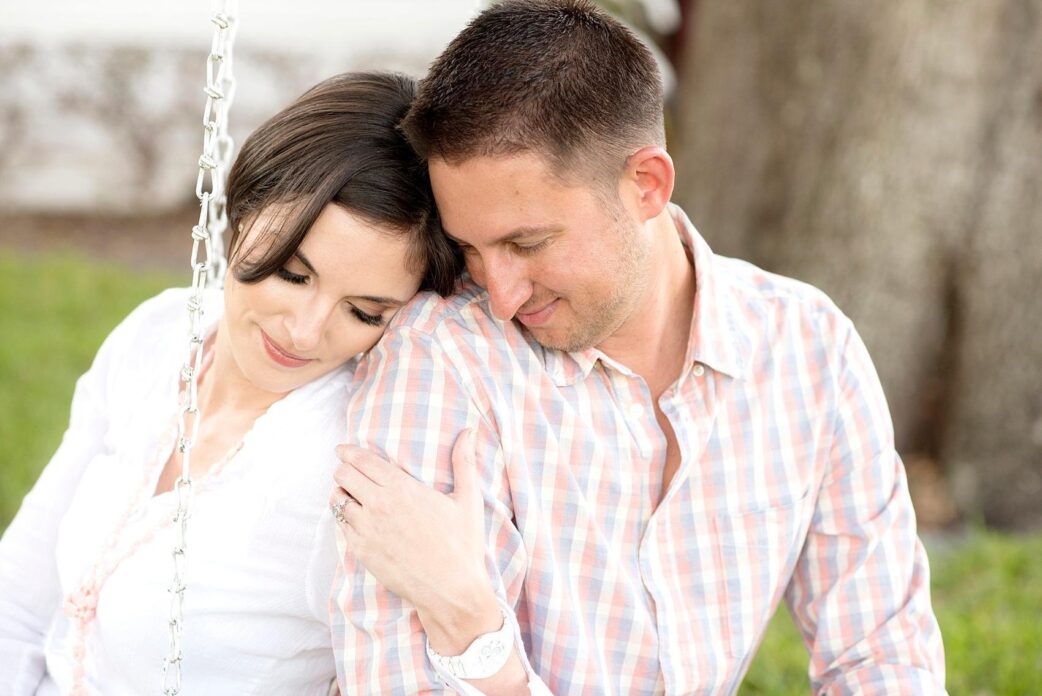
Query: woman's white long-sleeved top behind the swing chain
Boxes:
[{"xmin": 0, "ymin": 290, "xmax": 352, "ymax": 696}]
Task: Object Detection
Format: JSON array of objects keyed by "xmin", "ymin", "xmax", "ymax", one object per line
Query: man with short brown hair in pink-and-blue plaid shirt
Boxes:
[{"xmin": 334, "ymin": 0, "xmax": 944, "ymax": 694}]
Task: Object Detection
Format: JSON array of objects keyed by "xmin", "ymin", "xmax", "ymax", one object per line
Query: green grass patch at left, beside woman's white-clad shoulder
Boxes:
[{"xmin": 0, "ymin": 250, "xmax": 177, "ymax": 529}]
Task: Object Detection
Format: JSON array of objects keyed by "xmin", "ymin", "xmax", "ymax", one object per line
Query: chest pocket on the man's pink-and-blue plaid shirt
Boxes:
[{"xmin": 712, "ymin": 496, "xmax": 807, "ymax": 660}]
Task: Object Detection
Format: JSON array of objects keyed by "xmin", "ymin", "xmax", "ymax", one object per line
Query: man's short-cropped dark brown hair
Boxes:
[{"xmin": 402, "ymin": 0, "xmax": 665, "ymax": 184}]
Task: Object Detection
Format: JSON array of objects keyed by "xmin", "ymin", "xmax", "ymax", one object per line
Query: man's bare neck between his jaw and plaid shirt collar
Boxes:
[{"xmin": 597, "ymin": 209, "xmax": 695, "ymax": 397}]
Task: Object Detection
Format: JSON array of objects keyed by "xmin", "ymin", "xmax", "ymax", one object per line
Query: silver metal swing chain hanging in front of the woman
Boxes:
[{"xmin": 163, "ymin": 0, "xmax": 238, "ymax": 696}]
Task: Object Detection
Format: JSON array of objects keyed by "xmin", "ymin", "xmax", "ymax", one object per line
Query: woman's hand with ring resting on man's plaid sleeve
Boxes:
[{"xmin": 331, "ymin": 430, "xmax": 502, "ymax": 654}]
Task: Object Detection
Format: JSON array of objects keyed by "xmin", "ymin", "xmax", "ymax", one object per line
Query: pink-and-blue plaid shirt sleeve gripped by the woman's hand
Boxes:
[{"xmin": 330, "ymin": 327, "xmax": 549, "ymax": 695}]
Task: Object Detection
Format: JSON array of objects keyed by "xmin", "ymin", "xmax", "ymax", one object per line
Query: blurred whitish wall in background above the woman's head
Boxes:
[{"xmin": 0, "ymin": 0, "xmax": 478, "ymax": 212}]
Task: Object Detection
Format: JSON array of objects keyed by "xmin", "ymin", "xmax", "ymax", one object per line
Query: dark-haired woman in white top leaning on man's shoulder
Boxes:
[{"xmin": 0, "ymin": 74, "xmax": 468, "ymax": 696}]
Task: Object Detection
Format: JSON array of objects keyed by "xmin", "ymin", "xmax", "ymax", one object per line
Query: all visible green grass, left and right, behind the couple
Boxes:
[{"xmin": 0, "ymin": 251, "xmax": 1042, "ymax": 696}]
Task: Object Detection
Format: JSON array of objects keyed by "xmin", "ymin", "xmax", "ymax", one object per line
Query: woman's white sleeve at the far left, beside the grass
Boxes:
[{"xmin": 0, "ymin": 308, "xmax": 125, "ymax": 696}]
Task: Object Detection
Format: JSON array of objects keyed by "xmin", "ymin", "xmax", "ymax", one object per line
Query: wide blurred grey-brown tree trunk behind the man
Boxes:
[{"xmin": 671, "ymin": 0, "xmax": 1042, "ymax": 526}]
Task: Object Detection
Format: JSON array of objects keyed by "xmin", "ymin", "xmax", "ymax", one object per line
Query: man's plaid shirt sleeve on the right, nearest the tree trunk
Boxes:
[{"xmin": 786, "ymin": 322, "xmax": 946, "ymax": 695}]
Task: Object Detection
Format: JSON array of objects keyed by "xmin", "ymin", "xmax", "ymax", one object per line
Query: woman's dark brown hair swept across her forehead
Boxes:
[{"xmin": 227, "ymin": 73, "xmax": 462, "ymax": 295}]
